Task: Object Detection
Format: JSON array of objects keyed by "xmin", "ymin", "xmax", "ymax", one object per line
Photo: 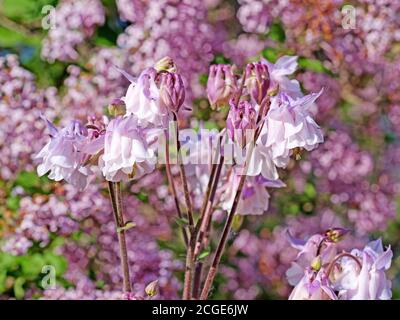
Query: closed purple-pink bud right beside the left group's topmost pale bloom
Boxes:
[{"xmin": 158, "ymin": 72, "xmax": 185, "ymax": 112}]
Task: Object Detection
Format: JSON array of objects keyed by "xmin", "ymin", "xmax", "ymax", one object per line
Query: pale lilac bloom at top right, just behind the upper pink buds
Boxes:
[{"xmin": 262, "ymin": 56, "xmax": 303, "ymax": 98}]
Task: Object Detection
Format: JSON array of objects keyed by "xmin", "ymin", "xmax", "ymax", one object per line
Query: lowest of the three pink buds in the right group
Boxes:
[{"xmin": 226, "ymin": 101, "xmax": 257, "ymax": 147}]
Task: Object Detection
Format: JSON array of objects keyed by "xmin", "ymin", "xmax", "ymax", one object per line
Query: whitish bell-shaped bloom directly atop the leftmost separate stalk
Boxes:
[{"xmin": 99, "ymin": 116, "xmax": 156, "ymax": 182}]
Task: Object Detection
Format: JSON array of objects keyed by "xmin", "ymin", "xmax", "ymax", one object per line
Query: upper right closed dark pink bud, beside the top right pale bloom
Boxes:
[{"xmin": 246, "ymin": 62, "xmax": 270, "ymax": 105}]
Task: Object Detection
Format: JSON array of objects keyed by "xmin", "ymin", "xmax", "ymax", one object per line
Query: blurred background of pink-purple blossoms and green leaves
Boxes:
[{"xmin": 0, "ymin": 0, "xmax": 400, "ymax": 299}]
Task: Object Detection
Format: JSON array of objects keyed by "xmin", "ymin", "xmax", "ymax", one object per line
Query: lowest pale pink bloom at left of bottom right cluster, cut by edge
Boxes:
[{"xmin": 289, "ymin": 269, "xmax": 337, "ymax": 300}]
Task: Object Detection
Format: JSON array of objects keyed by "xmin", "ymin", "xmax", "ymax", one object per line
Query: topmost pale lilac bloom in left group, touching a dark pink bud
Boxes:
[{"xmin": 121, "ymin": 68, "xmax": 168, "ymax": 127}]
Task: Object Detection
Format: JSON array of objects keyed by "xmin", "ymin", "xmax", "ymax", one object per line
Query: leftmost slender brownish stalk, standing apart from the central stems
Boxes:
[{"xmin": 108, "ymin": 181, "xmax": 132, "ymax": 292}]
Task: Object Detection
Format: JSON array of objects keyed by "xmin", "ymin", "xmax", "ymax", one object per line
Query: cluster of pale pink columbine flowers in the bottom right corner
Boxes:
[{"xmin": 286, "ymin": 228, "xmax": 393, "ymax": 300}]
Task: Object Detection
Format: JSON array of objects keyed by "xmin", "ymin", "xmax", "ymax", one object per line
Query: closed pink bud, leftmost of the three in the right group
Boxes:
[{"xmin": 207, "ymin": 64, "xmax": 237, "ymax": 109}]
